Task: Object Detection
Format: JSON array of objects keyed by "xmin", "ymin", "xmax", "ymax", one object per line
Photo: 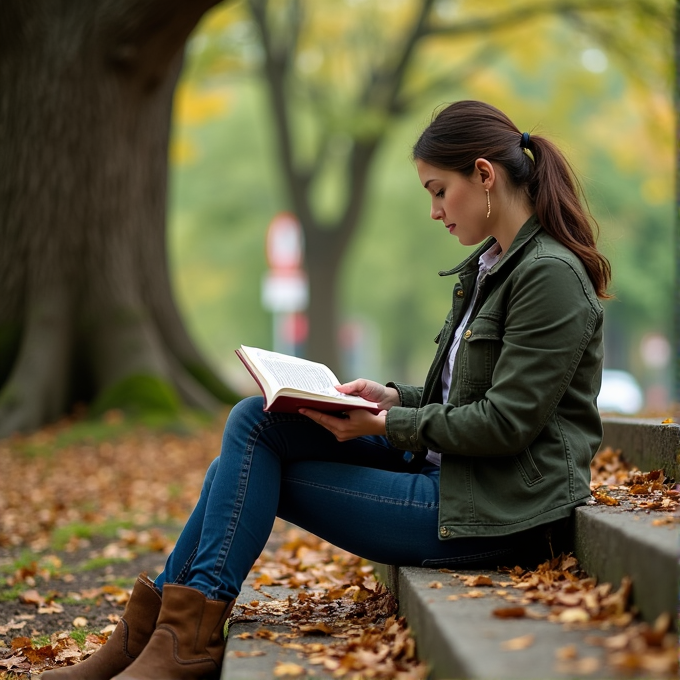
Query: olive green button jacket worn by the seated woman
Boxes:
[{"xmin": 386, "ymin": 216, "xmax": 603, "ymax": 539}]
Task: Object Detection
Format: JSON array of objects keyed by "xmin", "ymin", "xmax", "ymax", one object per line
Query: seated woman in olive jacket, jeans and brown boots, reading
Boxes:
[{"xmin": 45, "ymin": 101, "xmax": 610, "ymax": 680}]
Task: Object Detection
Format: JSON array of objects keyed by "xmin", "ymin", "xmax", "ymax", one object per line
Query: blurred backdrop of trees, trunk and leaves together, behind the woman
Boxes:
[{"xmin": 174, "ymin": 0, "xmax": 673, "ymax": 394}]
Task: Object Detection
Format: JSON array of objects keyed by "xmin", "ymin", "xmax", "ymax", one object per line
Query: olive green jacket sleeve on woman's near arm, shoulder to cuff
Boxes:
[{"xmin": 386, "ymin": 256, "xmax": 602, "ymax": 456}]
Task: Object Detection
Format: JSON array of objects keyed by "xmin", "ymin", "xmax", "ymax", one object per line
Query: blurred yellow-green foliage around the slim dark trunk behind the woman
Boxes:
[{"xmin": 170, "ymin": 0, "xmax": 674, "ymax": 385}]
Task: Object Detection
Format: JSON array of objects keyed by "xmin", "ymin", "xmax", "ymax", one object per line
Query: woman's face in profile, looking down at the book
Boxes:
[{"xmin": 416, "ymin": 159, "xmax": 493, "ymax": 246}]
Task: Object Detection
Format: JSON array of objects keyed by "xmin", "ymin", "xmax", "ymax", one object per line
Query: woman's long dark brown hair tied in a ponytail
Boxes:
[{"xmin": 413, "ymin": 101, "xmax": 611, "ymax": 298}]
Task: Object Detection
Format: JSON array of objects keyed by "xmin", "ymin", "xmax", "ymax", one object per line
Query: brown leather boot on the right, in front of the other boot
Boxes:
[{"xmin": 114, "ymin": 584, "xmax": 234, "ymax": 680}]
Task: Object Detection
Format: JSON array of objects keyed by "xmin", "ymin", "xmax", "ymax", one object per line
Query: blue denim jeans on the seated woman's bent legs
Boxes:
[{"xmin": 155, "ymin": 397, "xmax": 548, "ymax": 600}]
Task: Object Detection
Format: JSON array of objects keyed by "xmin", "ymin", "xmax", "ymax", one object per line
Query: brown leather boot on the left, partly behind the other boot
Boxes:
[{"xmin": 40, "ymin": 574, "xmax": 161, "ymax": 680}]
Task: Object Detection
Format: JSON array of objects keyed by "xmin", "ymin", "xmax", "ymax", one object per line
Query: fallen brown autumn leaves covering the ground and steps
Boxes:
[{"xmin": 0, "ymin": 413, "xmax": 679, "ymax": 680}]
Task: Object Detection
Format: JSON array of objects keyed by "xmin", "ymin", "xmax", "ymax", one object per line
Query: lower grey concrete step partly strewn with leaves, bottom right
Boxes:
[{"xmin": 398, "ymin": 567, "xmax": 620, "ymax": 680}]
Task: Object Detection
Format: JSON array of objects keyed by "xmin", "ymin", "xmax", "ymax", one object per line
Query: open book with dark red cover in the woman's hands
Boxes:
[{"xmin": 236, "ymin": 345, "xmax": 381, "ymax": 413}]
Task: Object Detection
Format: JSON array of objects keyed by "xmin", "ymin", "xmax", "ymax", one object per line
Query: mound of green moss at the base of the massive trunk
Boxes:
[{"xmin": 92, "ymin": 375, "xmax": 181, "ymax": 417}]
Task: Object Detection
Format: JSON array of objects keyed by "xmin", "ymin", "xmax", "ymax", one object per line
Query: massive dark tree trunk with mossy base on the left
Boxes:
[{"xmin": 0, "ymin": 0, "xmax": 239, "ymax": 436}]
